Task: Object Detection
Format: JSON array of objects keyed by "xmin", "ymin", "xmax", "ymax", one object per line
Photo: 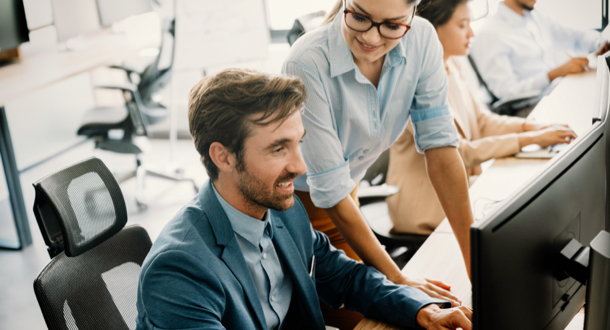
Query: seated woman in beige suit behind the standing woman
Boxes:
[{"xmin": 387, "ymin": 0, "xmax": 576, "ymax": 234}]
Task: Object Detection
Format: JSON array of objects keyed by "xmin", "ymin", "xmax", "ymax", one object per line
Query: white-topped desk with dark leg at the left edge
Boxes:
[{"xmin": 0, "ymin": 28, "xmax": 159, "ymax": 249}]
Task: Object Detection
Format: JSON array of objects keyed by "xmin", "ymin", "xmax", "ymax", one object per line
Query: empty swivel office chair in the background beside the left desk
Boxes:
[{"xmin": 78, "ymin": 20, "xmax": 198, "ymax": 210}]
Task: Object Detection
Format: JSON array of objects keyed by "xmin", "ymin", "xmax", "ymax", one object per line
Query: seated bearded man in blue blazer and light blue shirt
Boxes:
[{"xmin": 137, "ymin": 69, "xmax": 472, "ymax": 330}]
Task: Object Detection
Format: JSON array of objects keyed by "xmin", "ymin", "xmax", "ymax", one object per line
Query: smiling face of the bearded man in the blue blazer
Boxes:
[{"xmin": 234, "ymin": 111, "xmax": 306, "ymax": 213}]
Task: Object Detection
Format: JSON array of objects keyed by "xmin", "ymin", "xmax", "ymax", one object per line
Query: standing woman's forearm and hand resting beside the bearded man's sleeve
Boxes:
[{"xmin": 325, "ymin": 196, "xmax": 461, "ymax": 306}]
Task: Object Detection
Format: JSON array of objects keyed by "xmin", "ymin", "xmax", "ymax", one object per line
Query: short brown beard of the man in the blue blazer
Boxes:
[{"xmin": 237, "ymin": 167, "xmax": 298, "ymax": 211}]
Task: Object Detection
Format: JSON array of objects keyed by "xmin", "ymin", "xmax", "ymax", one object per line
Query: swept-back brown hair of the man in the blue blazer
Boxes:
[{"xmin": 188, "ymin": 69, "xmax": 305, "ymax": 181}]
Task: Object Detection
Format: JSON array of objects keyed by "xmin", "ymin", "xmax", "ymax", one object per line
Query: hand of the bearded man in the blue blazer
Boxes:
[{"xmin": 417, "ymin": 304, "xmax": 472, "ymax": 330}]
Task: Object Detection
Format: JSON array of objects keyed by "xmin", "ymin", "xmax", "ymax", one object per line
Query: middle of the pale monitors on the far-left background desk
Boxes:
[{"xmin": 51, "ymin": 0, "xmax": 100, "ymax": 42}]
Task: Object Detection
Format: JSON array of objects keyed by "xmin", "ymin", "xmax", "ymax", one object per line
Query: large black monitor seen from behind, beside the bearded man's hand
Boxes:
[{"xmin": 471, "ymin": 112, "xmax": 607, "ymax": 330}]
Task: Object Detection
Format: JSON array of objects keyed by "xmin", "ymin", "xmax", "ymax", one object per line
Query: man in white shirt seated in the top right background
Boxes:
[{"xmin": 471, "ymin": 0, "xmax": 608, "ymax": 117}]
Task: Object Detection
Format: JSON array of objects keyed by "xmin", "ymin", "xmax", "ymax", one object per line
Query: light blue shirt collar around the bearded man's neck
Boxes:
[{"xmin": 212, "ymin": 184, "xmax": 273, "ymax": 246}]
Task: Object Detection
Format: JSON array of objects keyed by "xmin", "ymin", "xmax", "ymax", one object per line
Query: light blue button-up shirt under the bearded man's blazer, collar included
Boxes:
[{"xmin": 212, "ymin": 184, "xmax": 292, "ymax": 329}]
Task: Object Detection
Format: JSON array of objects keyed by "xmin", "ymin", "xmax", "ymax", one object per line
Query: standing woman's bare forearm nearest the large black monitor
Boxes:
[{"xmin": 425, "ymin": 147, "xmax": 474, "ymax": 277}]
